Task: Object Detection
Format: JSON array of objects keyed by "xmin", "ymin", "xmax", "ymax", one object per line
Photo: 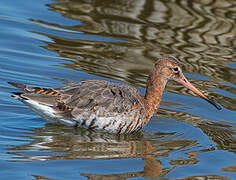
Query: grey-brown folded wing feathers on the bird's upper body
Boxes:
[{"xmin": 58, "ymin": 80, "xmax": 144, "ymax": 116}]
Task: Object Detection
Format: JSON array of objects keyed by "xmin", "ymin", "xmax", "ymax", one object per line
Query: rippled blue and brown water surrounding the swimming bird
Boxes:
[{"xmin": 0, "ymin": 0, "xmax": 236, "ymax": 180}]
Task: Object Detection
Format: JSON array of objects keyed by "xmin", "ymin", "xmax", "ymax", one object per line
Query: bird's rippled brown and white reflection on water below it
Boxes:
[{"xmin": 8, "ymin": 124, "xmax": 196, "ymax": 179}]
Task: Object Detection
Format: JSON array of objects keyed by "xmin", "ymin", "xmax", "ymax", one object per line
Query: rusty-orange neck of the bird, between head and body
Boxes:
[{"xmin": 144, "ymin": 75, "xmax": 167, "ymax": 123}]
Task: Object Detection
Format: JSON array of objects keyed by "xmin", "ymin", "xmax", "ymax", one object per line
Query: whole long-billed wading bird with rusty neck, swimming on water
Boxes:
[{"xmin": 9, "ymin": 57, "xmax": 220, "ymax": 133}]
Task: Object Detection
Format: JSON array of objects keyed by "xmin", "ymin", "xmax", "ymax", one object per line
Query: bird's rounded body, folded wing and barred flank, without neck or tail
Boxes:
[{"xmin": 57, "ymin": 80, "xmax": 145, "ymax": 133}]
